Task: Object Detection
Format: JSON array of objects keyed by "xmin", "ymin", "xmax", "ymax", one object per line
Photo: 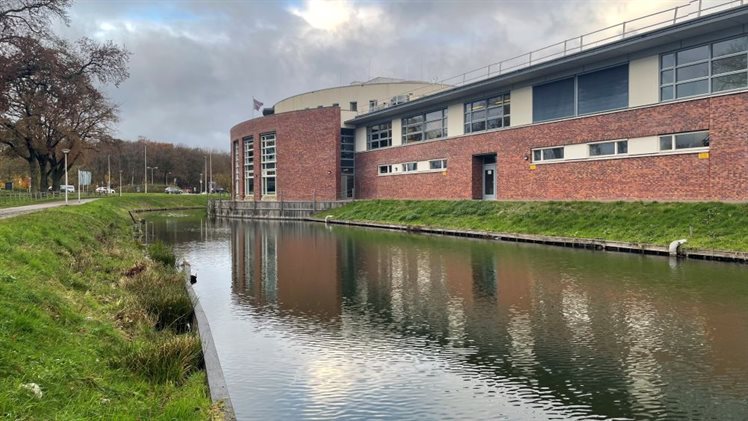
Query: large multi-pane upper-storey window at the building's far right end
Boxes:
[{"xmin": 660, "ymin": 36, "xmax": 748, "ymax": 101}]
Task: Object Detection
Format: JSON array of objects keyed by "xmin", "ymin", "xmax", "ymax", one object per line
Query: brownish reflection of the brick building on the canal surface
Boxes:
[{"xmin": 226, "ymin": 222, "xmax": 748, "ymax": 418}]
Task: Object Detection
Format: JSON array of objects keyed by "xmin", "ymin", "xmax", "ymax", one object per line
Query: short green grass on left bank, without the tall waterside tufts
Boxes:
[{"xmin": 0, "ymin": 195, "xmax": 210, "ymax": 419}]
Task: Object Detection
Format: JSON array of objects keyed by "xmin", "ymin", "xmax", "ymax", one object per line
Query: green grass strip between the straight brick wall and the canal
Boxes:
[{"xmin": 317, "ymin": 200, "xmax": 748, "ymax": 251}]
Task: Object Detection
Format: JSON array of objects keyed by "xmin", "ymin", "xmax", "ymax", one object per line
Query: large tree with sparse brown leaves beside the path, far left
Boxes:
[{"xmin": 0, "ymin": 38, "xmax": 129, "ymax": 190}]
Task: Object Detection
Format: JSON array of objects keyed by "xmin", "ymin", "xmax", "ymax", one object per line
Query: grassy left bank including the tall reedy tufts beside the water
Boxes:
[{"xmin": 0, "ymin": 195, "xmax": 216, "ymax": 420}]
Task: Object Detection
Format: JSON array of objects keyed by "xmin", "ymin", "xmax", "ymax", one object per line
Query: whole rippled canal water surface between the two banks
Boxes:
[{"xmin": 149, "ymin": 214, "xmax": 748, "ymax": 420}]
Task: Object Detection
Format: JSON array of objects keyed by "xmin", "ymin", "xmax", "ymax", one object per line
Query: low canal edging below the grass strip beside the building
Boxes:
[{"xmin": 303, "ymin": 217, "xmax": 748, "ymax": 263}]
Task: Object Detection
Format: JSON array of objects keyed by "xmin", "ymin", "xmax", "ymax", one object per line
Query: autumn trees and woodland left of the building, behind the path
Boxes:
[{"xmin": 0, "ymin": 0, "xmax": 230, "ymax": 191}]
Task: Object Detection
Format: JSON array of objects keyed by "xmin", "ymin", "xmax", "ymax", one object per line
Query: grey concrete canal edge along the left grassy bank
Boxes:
[{"xmin": 181, "ymin": 262, "xmax": 236, "ymax": 421}]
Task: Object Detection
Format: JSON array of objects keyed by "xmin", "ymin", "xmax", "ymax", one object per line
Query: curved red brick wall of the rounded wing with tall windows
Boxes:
[{"xmin": 231, "ymin": 107, "xmax": 340, "ymax": 200}]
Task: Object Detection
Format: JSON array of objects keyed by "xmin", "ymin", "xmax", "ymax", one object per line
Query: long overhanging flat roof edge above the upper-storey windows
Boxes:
[{"xmin": 345, "ymin": 5, "xmax": 748, "ymax": 125}]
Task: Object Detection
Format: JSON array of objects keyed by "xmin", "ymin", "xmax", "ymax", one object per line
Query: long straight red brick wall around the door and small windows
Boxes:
[{"xmin": 356, "ymin": 93, "xmax": 748, "ymax": 201}]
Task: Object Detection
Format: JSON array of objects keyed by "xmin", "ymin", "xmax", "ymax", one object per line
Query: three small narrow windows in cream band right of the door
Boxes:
[{"xmin": 532, "ymin": 132, "xmax": 709, "ymax": 162}]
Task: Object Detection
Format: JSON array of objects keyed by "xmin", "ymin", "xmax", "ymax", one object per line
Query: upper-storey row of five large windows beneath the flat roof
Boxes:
[{"xmin": 367, "ymin": 35, "xmax": 748, "ymax": 150}]
